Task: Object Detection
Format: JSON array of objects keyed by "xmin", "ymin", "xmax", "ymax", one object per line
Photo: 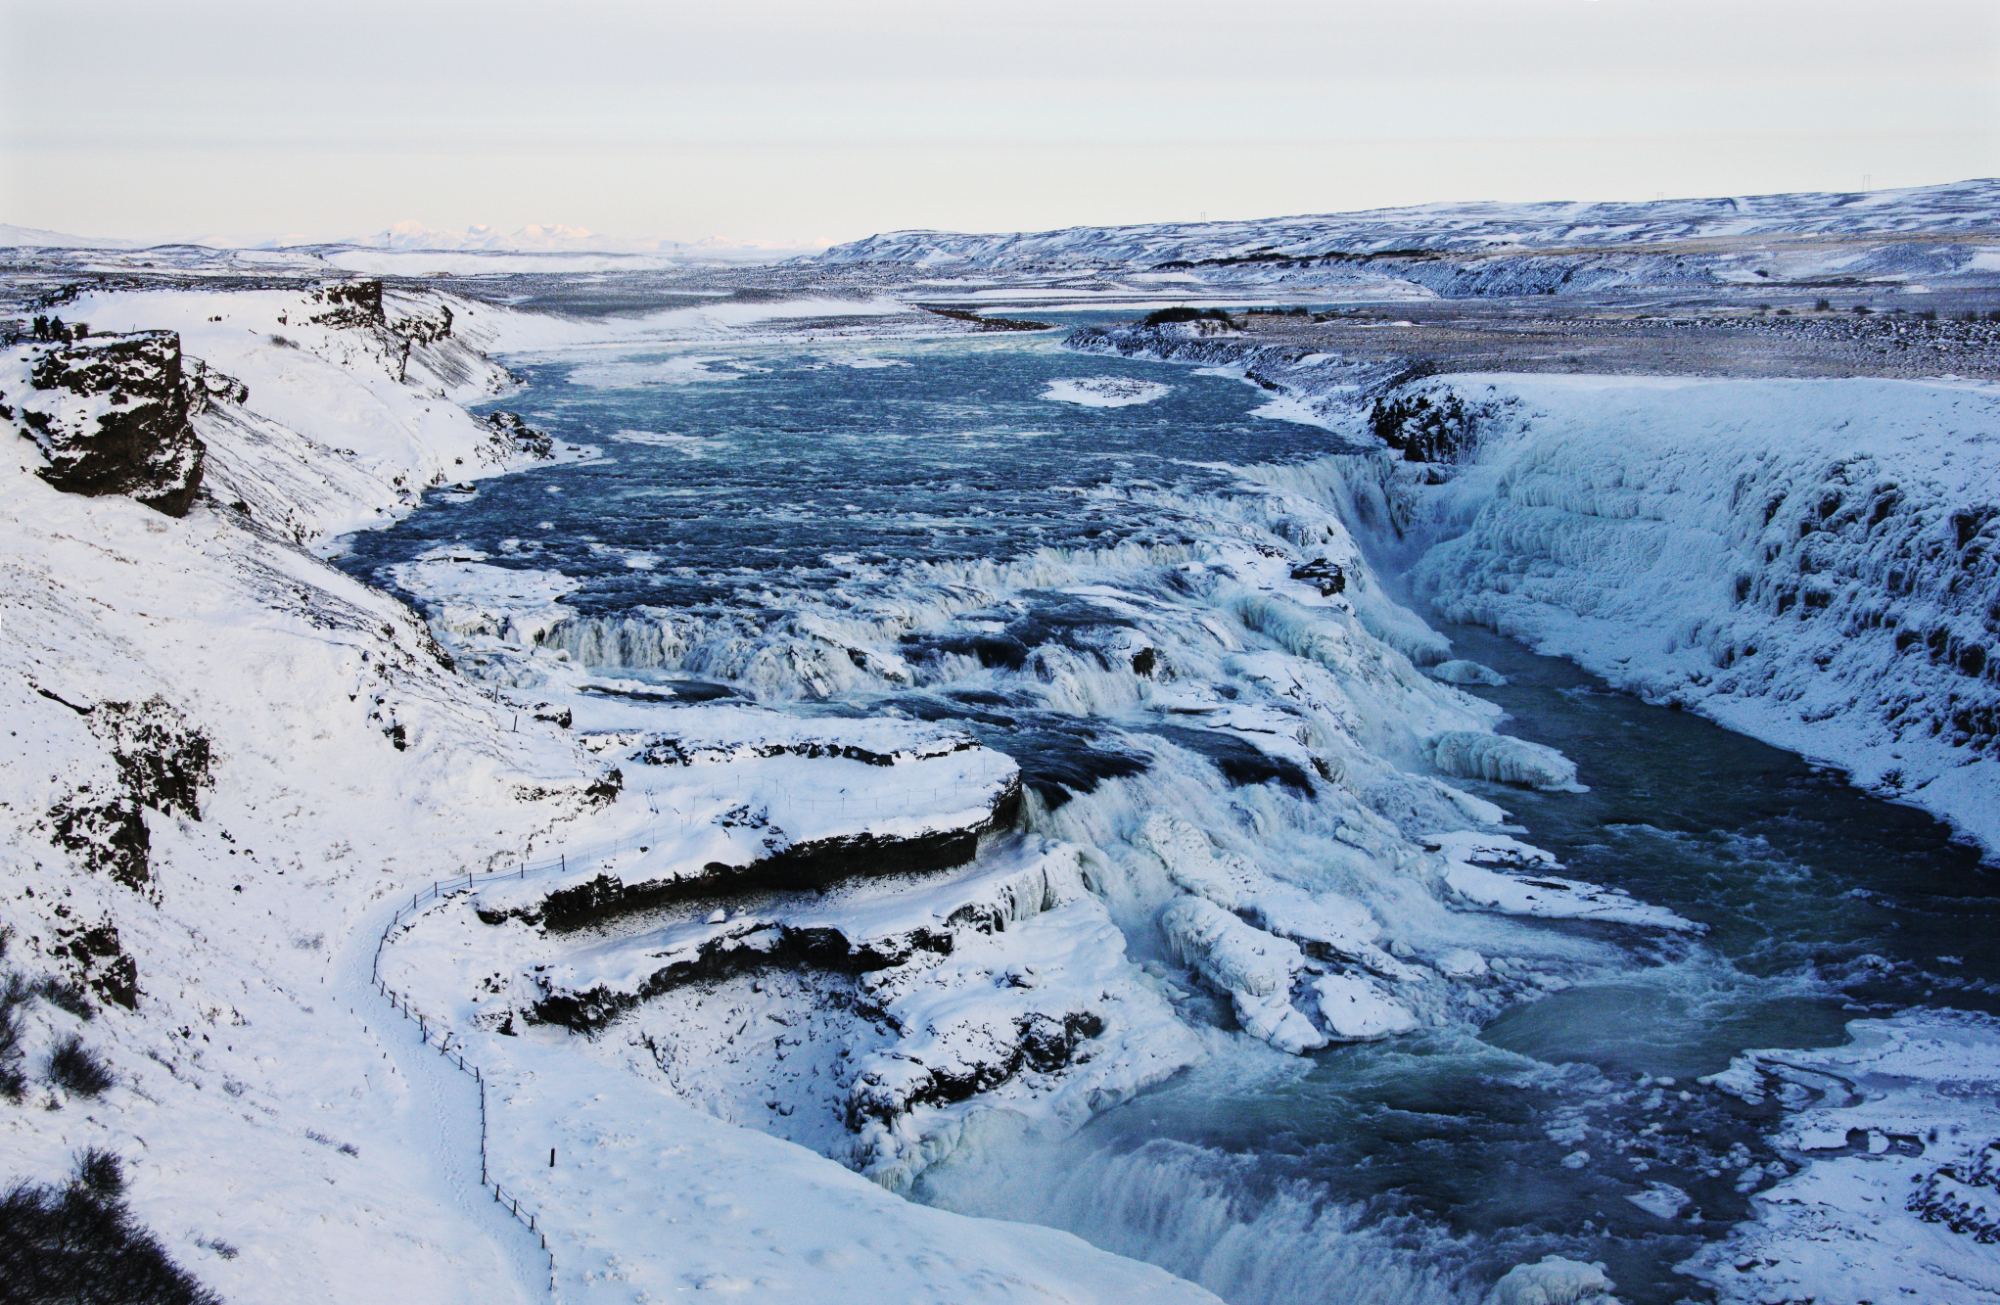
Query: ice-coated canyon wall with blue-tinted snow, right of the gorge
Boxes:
[{"xmin": 1412, "ymin": 376, "xmax": 2000, "ymax": 849}]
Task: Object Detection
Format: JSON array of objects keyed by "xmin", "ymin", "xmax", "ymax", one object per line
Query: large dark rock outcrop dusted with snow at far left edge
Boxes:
[{"xmin": 0, "ymin": 330, "xmax": 208, "ymax": 516}]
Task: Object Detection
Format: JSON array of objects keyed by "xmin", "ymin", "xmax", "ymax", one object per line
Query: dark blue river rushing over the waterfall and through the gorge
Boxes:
[{"xmin": 348, "ymin": 326, "xmax": 2000, "ymax": 1305}]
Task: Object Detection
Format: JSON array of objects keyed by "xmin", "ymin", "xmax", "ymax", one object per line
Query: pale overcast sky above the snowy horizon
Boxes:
[{"xmin": 0, "ymin": 0, "xmax": 2000, "ymax": 242}]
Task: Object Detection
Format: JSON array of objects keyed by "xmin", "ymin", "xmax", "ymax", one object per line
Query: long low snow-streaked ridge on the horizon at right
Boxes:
[{"xmin": 818, "ymin": 180, "xmax": 2000, "ymax": 270}]
